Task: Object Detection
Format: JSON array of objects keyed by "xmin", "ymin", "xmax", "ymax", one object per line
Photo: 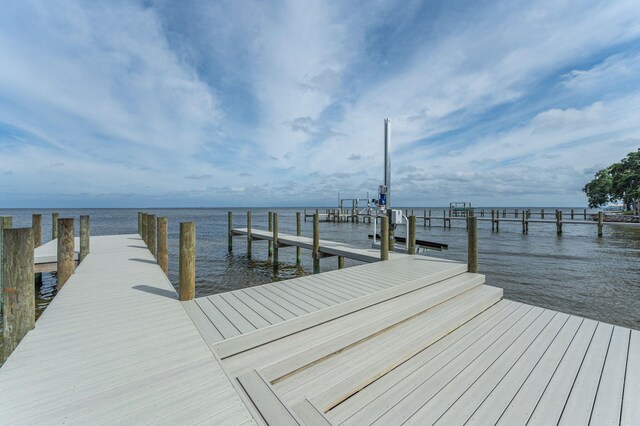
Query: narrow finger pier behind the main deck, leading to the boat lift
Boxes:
[{"xmin": 232, "ymin": 228, "xmax": 404, "ymax": 263}]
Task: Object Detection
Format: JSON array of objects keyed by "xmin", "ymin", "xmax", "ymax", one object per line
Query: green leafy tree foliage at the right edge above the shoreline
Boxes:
[{"xmin": 582, "ymin": 149, "xmax": 640, "ymax": 210}]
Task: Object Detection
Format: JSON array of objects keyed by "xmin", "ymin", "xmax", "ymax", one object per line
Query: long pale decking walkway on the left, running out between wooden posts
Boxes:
[{"xmin": 0, "ymin": 235, "xmax": 253, "ymax": 425}]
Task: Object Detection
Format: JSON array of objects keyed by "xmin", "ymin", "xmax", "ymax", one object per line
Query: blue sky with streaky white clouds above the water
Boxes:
[{"xmin": 0, "ymin": 0, "xmax": 640, "ymax": 207}]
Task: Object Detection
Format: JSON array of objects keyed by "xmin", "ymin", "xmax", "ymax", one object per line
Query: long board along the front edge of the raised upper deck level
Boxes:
[{"xmin": 214, "ymin": 271, "xmax": 468, "ymax": 358}]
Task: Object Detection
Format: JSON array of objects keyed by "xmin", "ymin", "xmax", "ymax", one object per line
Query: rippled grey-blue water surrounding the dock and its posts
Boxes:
[{"xmin": 0, "ymin": 208, "xmax": 640, "ymax": 350}]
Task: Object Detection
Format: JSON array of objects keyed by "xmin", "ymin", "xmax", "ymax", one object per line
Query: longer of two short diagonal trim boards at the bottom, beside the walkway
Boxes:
[{"xmin": 238, "ymin": 370, "xmax": 304, "ymax": 426}]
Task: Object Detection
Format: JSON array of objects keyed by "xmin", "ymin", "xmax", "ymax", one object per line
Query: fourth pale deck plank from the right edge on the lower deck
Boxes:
[{"xmin": 524, "ymin": 319, "xmax": 598, "ymax": 426}]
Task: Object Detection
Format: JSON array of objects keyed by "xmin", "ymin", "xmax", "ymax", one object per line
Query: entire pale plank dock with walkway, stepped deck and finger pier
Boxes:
[{"xmin": 0, "ymin": 229, "xmax": 640, "ymax": 425}]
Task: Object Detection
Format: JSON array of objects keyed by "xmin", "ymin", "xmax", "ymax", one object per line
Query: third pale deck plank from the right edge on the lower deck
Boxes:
[{"xmin": 559, "ymin": 323, "xmax": 613, "ymax": 425}]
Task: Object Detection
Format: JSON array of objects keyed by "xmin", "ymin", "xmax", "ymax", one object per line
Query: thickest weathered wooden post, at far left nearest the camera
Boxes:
[{"xmin": 0, "ymin": 228, "xmax": 36, "ymax": 360}]
